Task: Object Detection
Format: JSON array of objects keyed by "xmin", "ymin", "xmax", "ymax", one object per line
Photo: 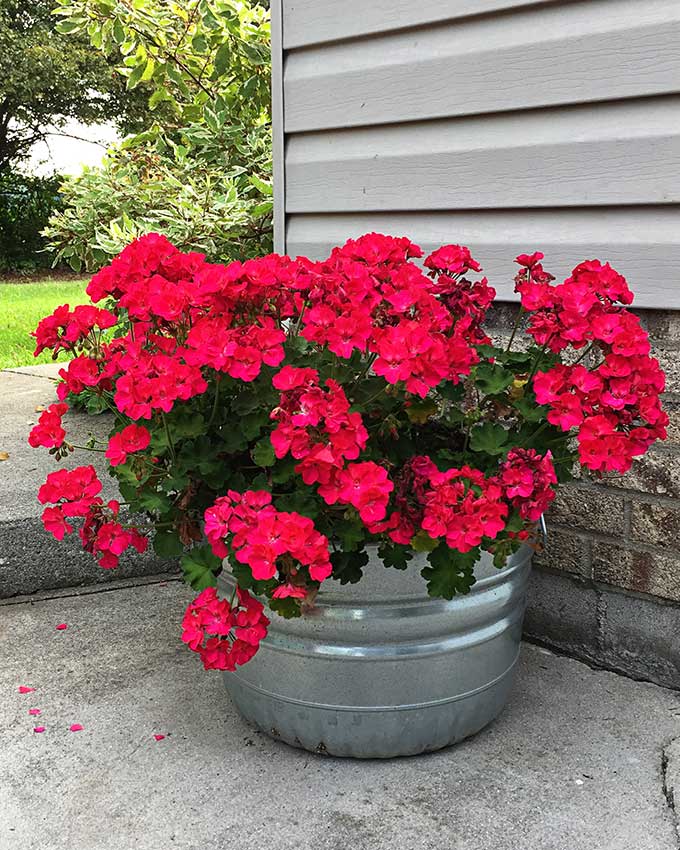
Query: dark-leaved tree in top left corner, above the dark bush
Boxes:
[{"xmin": 0, "ymin": 0, "xmax": 149, "ymax": 171}]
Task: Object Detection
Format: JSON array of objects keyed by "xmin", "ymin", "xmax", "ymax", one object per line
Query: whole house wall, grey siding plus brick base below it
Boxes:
[{"xmin": 272, "ymin": 0, "xmax": 680, "ymax": 687}]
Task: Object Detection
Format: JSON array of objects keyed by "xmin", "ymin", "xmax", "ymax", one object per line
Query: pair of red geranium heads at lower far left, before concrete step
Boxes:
[{"xmin": 38, "ymin": 466, "xmax": 149, "ymax": 569}]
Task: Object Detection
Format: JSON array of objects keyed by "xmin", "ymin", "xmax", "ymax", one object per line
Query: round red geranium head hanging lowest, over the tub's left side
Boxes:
[{"xmin": 182, "ymin": 587, "xmax": 269, "ymax": 671}]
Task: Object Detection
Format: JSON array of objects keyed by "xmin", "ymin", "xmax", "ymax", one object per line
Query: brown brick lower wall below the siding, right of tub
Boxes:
[{"xmin": 490, "ymin": 304, "xmax": 680, "ymax": 687}]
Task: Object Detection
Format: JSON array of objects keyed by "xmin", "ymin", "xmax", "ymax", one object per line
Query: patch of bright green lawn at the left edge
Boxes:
[{"xmin": 0, "ymin": 280, "xmax": 90, "ymax": 369}]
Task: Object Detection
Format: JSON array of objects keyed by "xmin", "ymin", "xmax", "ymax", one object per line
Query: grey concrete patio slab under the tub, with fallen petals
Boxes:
[{"xmin": 0, "ymin": 577, "xmax": 680, "ymax": 850}]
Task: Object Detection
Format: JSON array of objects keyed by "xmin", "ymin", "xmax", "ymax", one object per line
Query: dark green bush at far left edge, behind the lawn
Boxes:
[{"xmin": 0, "ymin": 171, "xmax": 63, "ymax": 272}]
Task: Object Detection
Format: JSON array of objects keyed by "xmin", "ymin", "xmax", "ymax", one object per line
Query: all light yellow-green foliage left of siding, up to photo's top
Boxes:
[{"xmin": 45, "ymin": 0, "xmax": 272, "ymax": 270}]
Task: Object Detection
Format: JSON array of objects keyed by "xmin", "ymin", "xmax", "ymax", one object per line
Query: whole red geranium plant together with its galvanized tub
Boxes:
[{"xmin": 30, "ymin": 233, "xmax": 667, "ymax": 756}]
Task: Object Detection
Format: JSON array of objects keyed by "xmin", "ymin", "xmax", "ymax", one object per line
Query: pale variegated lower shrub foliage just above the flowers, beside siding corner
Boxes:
[{"xmin": 44, "ymin": 119, "xmax": 272, "ymax": 271}]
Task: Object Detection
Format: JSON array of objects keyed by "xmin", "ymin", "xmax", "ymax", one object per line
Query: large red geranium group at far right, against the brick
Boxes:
[{"xmin": 517, "ymin": 254, "xmax": 668, "ymax": 473}]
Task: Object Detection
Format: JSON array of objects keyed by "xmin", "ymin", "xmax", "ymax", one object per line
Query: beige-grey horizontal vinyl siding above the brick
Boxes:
[{"xmin": 275, "ymin": 0, "xmax": 680, "ymax": 308}]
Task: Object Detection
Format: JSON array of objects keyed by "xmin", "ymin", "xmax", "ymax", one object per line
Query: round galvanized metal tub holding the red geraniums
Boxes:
[{"xmin": 221, "ymin": 546, "xmax": 532, "ymax": 758}]
